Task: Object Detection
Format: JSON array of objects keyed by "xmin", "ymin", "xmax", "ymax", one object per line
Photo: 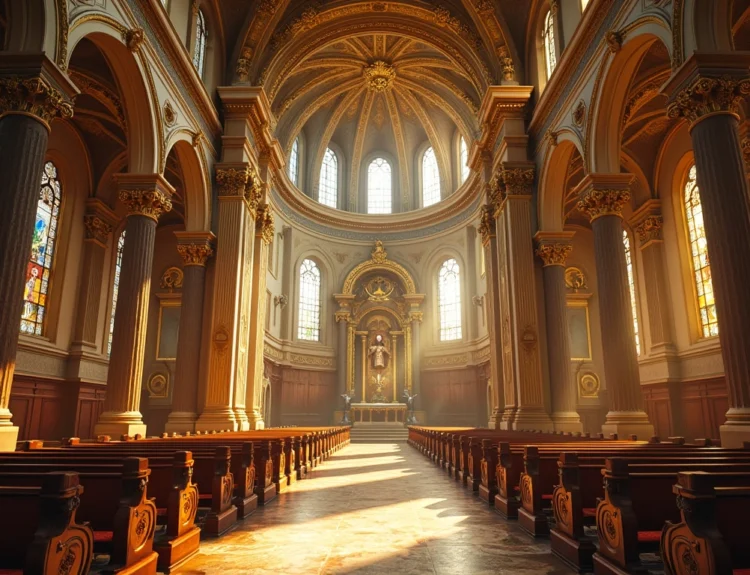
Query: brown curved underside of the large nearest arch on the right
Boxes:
[{"xmin": 584, "ymin": 19, "xmax": 672, "ymax": 174}]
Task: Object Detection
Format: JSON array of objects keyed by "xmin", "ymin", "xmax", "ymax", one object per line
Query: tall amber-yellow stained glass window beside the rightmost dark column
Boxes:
[{"xmin": 685, "ymin": 166, "xmax": 719, "ymax": 337}]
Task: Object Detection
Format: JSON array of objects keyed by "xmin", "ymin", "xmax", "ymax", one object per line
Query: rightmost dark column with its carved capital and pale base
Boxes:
[{"xmin": 665, "ymin": 53, "xmax": 750, "ymax": 447}]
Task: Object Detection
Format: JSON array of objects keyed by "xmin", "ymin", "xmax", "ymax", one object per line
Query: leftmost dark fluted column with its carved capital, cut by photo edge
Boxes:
[{"xmin": 0, "ymin": 60, "xmax": 73, "ymax": 451}]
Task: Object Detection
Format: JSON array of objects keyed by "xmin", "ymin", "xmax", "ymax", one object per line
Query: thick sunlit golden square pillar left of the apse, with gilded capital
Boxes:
[{"xmin": 195, "ymin": 163, "xmax": 261, "ymax": 431}]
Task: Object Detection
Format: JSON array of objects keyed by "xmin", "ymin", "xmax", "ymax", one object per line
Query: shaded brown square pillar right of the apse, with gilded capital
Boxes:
[{"xmin": 497, "ymin": 162, "xmax": 552, "ymax": 429}]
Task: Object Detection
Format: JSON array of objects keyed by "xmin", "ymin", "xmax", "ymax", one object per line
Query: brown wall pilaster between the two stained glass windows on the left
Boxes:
[{"xmin": 73, "ymin": 198, "xmax": 117, "ymax": 348}]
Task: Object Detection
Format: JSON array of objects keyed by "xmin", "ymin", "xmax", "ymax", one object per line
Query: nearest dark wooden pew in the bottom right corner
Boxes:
[{"xmin": 660, "ymin": 472, "xmax": 750, "ymax": 575}]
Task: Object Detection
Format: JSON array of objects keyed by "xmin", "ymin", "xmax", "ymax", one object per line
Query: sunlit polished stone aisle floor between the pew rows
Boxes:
[{"xmin": 178, "ymin": 443, "xmax": 572, "ymax": 575}]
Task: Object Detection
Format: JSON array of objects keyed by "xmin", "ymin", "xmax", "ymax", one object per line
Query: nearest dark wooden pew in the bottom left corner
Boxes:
[{"xmin": 0, "ymin": 472, "xmax": 94, "ymax": 575}]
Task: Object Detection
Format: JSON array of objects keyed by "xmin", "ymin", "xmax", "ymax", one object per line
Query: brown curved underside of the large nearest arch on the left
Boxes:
[{"xmin": 68, "ymin": 16, "xmax": 161, "ymax": 174}]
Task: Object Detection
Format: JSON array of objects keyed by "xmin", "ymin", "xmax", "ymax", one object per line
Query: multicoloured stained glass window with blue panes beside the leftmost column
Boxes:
[{"xmin": 21, "ymin": 162, "xmax": 62, "ymax": 335}]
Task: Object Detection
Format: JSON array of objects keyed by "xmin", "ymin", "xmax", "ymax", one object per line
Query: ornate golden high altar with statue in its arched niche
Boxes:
[{"xmin": 334, "ymin": 241, "xmax": 424, "ymax": 423}]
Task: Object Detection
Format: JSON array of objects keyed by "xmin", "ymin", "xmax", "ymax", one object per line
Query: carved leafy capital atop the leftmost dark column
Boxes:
[{"xmin": 0, "ymin": 77, "xmax": 73, "ymax": 129}]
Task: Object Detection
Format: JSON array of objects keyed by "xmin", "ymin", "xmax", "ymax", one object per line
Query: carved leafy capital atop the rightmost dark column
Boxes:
[{"xmin": 667, "ymin": 76, "xmax": 750, "ymax": 125}]
